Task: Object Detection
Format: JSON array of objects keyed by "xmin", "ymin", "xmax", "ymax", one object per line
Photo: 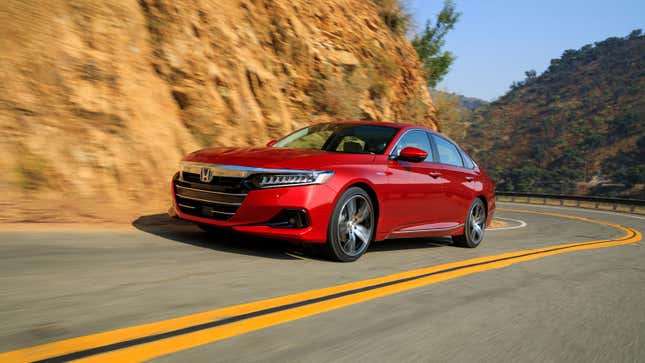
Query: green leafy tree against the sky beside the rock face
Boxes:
[{"xmin": 412, "ymin": 0, "xmax": 461, "ymax": 88}]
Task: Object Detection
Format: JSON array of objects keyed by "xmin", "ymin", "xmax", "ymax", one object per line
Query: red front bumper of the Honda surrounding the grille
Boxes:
[{"xmin": 168, "ymin": 182, "xmax": 336, "ymax": 243}]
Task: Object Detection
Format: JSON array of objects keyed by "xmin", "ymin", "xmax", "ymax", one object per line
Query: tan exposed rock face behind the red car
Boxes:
[{"xmin": 0, "ymin": 0, "xmax": 436, "ymax": 221}]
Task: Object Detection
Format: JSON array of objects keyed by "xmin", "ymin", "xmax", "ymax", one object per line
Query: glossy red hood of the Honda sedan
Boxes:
[{"xmin": 184, "ymin": 147, "xmax": 374, "ymax": 170}]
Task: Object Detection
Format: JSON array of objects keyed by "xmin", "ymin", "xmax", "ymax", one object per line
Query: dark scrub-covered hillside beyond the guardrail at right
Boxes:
[{"xmin": 453, "ymin": 30, "xmax": 645, "ymax": 197}]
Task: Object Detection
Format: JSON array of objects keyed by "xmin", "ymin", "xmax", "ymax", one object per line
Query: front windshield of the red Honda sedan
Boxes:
[{"xmin": 273, "ymin": 124, "xmax": 398, "ymax": 154}]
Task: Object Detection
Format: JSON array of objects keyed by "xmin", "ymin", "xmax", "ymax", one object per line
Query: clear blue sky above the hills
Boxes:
[{"xmin": 403, "ymin": 0, "xmax": 645, "ymax": 100}]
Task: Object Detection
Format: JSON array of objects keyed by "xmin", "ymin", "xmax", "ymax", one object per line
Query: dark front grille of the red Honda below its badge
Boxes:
[{"xmin": 174, "ymin": 173, "xmax": 248, "ymax": 220}]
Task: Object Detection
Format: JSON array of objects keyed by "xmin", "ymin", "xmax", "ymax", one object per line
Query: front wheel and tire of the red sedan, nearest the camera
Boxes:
[{"xmin": 325, "ymin": 187, "xmax": 376, "ymax": 262}]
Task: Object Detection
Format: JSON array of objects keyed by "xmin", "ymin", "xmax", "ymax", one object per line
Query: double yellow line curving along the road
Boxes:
[{"xmin": 0, "ymin": 209, "xmax": 642, "ymax": 363}]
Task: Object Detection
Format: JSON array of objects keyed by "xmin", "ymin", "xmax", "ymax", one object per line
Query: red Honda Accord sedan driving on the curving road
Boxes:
[{"xmin": 169, "ymin": 122, "xmax": 495, "ymax": 261}]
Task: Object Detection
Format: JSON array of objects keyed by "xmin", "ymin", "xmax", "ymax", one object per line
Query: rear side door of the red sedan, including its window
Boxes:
[{"xmin": 430, "ymin": 133, "xmax": 481, "ymax": 224}]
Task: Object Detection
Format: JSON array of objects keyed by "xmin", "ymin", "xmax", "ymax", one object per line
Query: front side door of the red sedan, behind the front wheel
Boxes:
[{"xmin": 384, "ymin": 129, "xmax": 445, "ymax": 233}]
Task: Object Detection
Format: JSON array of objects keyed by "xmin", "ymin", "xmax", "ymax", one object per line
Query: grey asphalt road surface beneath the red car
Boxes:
[{"xmin": 0, "ymin": 203, "xmax": 645, "ymax": 362}]
